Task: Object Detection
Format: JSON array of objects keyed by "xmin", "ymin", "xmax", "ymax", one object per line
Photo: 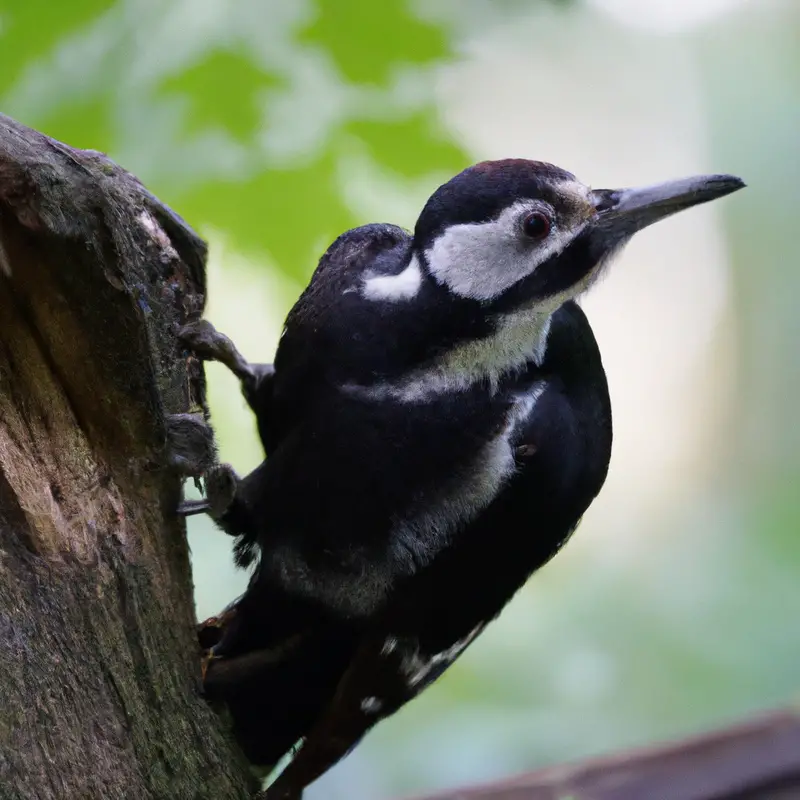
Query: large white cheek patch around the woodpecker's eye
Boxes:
[{"xmin": 425, "ymin": 201, "xmax": 583, "ymax": 300}]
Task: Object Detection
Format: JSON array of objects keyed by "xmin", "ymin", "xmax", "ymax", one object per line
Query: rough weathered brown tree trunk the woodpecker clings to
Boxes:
[{"xmin": 0, "ymin": 116, "xmax": 253, "ymax": 800}]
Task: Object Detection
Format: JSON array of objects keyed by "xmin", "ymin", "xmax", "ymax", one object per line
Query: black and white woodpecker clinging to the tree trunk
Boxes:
[{"xmin": 179, "ymin": 159, "xmax": 744, "ymax": 800}]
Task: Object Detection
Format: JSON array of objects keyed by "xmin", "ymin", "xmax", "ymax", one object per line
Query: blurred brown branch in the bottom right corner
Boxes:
[{"xmin": 416, "ymin": 711, "xmax": 800, "ymax": 800}]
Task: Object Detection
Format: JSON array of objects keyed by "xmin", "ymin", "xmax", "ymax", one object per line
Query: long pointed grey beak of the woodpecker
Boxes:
[{"xmin": 592, "ymin": 175, "xmax": 745, "ymax": 244}]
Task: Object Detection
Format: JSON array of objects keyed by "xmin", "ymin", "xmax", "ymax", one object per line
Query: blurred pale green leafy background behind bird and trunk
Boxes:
[{"xmin": 0, "ymin": 0, "xmax": 800, "ymax": 800}]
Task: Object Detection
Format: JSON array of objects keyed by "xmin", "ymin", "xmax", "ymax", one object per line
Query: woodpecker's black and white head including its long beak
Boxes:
[{"xmin": 414, "ymin": 159, "xmax": 744, "ymax": 312}]
